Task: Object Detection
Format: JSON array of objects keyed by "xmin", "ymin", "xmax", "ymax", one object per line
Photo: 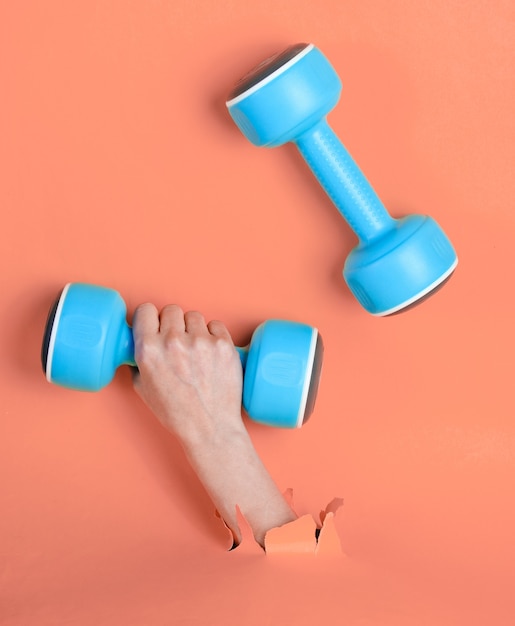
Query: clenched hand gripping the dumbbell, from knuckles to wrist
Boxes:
[{"xmin": 133, "ymin": 304, "xmax": 244, "ymax": 448}]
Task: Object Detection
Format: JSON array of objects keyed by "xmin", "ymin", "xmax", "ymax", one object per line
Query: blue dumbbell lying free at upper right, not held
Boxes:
[{"xmin": 226, "ymin": 43, "xmax": 458, "ymax": 315}]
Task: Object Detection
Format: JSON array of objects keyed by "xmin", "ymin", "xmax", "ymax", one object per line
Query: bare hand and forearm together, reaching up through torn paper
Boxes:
[{"xmin": 133, "ymin": 303, "xmax": 296, "ymax": 546}]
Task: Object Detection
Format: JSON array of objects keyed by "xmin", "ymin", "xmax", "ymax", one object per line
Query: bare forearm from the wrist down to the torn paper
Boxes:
[{"xmin": 183, "ymin": 427, "xmax": 296, "ymax": 546}]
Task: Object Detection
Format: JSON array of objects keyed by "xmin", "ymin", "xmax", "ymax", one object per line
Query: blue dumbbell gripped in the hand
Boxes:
[{"xmin": 41, "ymin": 283, "xmax": 323, "ymax": 428}]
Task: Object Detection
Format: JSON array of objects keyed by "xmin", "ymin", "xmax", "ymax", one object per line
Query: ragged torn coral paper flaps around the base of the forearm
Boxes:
[{"xmin": 215, "ymin": 489, "xmax": 343, "ymax": 556}]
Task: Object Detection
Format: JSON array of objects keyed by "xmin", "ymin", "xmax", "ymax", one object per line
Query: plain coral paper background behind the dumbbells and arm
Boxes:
[{"xmin": 0, "ymin": 0, "xmax": 515, "ymax": 626}]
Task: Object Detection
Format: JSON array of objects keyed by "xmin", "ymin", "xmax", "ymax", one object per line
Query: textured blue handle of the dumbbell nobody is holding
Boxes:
[{"xmin": 295, "ymin": 119, "xmax": 395, "ymax": 242}]
